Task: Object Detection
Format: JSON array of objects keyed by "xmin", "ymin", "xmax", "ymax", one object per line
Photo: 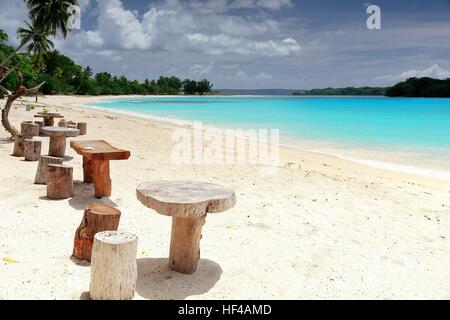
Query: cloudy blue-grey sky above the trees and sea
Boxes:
[{"xmin": 0, "ymin": 0, "xmax": 450, "ymax": 89}]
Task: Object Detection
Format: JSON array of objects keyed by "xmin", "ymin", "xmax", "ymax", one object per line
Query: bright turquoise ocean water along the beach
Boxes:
[{"xmin": 91, "ymin": 96, "xmax": 450, "ymax": 178}]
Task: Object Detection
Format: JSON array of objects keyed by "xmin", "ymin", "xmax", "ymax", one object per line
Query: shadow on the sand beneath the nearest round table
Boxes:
[{"xmin": 136, "ymin": 258, "xmax": 222, "ymax": 300}]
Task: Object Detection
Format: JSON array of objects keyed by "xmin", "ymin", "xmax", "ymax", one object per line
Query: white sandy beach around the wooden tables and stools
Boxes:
[{"xmin": 0, "ymin": 96, "xmax": 450, "ymax": 299}]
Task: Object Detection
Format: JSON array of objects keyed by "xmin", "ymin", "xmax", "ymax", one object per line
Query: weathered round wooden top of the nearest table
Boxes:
[{"xmin": 136, "ymin": 181, "xmax": 236, "ymax": 218}]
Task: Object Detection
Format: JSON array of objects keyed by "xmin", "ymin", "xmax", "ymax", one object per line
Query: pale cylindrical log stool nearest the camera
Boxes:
[{"xmin": 89, "ymin": 231, "xmax": 138, "ymax": 300}]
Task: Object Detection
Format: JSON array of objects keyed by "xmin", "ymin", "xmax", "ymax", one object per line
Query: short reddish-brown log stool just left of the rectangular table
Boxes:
[{"xmin": 47, "ymin": 164, "xmax": 73, "ymax": 200}]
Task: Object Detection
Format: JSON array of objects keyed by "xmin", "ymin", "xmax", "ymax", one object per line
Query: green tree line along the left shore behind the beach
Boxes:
[{"xmin": 0, "ymin": 29, "xmax": 213, "ymax": 99}]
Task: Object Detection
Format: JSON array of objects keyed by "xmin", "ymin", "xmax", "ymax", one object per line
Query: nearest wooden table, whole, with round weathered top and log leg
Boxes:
[{"xmin": 136, "ymin": 181, "xmax": 236, "ymax": 274}]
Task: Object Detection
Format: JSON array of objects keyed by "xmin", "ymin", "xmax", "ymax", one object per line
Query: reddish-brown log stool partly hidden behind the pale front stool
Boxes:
[{"xmin": 73, "ymin": 204, "xmax": 120, "ymax": 261}]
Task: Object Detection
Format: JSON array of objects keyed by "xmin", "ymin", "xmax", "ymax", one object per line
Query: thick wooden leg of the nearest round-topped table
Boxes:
[{"xmin": 169, "ymin": 214, "xmax": 206, "ymax": 274}]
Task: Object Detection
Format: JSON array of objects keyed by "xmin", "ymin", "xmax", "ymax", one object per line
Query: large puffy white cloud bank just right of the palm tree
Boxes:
[{"xmin": 59, "ymin": 0, "xmax": 301, "ymax": 56}]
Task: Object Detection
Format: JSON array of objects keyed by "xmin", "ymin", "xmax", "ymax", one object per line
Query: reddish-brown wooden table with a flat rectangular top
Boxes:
[{"xmin": 70, "ymin": 140, "xmax": 130, "ymax": 199}]
